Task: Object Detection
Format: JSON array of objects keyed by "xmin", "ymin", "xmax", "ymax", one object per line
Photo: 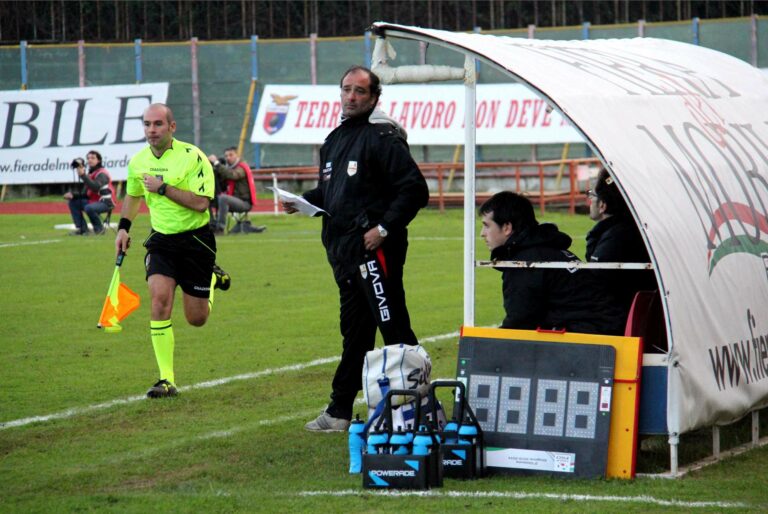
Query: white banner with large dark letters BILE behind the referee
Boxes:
[{"xmin": 0, "ymin": 82, "xmax": 168, "ymax": 184}]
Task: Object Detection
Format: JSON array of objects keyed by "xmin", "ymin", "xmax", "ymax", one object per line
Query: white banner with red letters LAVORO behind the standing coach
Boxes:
[{"xmin": 251, "ymin": 84, "xmax": 582, "ymax": 145}]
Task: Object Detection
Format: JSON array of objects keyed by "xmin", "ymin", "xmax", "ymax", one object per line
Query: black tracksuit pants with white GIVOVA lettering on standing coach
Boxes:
[{"xmin": 326, "ymin": 243, "xmax": 418, "ymax": 419}]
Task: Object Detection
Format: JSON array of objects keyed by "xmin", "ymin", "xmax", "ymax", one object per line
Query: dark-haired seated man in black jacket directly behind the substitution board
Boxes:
[{"xmin": 480, "ymin": 191, "xmax": 624, "ymax": 335}]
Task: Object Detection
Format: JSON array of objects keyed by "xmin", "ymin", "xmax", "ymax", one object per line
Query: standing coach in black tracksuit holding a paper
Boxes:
[{"xmin": 284, "ymin": 66, "xmax": 429, "ymax": 431}]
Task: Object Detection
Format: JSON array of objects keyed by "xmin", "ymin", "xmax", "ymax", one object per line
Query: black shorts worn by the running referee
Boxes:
[{"xmin": 144, "ymin": 224, "xmax": 216, "ymax": 298}]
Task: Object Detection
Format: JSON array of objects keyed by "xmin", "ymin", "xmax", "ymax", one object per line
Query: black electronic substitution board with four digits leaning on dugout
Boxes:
[{"xmin": 457, "ymin": 335, "xmax": 616, "ymax": 477}]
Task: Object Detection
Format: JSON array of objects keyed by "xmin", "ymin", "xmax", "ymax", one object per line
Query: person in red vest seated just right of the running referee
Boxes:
[{"xmin": 208, "ymin": 146, "xmax": 266, "ymax": 234}]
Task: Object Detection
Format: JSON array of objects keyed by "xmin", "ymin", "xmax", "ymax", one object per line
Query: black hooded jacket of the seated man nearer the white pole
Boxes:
[{"xmin": 491, "ymin": 223, "xmax": 624, "ymax": 335}]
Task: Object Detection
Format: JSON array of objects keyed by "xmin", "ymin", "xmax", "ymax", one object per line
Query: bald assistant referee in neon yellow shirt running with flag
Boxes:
[{"xmin": 115, "ymin": 104, "xmax": 230, "ymax": 398}]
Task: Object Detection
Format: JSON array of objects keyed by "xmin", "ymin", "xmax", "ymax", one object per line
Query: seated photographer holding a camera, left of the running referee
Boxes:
[{"xmin": 64, "ymin": 150, "xmax": 115, "ymax": 236}]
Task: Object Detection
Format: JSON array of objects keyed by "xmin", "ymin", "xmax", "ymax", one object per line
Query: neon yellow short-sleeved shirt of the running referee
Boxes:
[{"xmin": 126, "ymin": 139, "xmax": 214, "ymax": 234}]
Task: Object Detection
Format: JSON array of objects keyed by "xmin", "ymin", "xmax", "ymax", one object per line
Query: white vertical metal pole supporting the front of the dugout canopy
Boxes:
[{"xmin": 464, "ymin": 55, "xmax": 477, "ymax": 327}]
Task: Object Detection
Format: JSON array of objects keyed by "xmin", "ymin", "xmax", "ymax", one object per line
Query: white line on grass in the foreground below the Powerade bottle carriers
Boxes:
[{"xmin": 299, "ymin": 489, "xmax": 750, "ymax": 509}]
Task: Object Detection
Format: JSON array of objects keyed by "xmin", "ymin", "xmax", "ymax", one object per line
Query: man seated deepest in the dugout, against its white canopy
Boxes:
[{"xmin": 586, "ymin": 168, "xmax": 657, "ymax": 320}]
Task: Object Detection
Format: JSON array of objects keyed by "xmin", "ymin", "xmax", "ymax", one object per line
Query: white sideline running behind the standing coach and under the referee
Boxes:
[{"xmin": 0, "ymin": 332, "xmax": 459, "ymax": 430}]
